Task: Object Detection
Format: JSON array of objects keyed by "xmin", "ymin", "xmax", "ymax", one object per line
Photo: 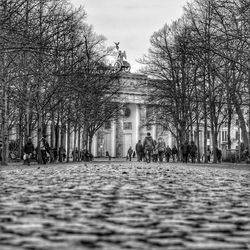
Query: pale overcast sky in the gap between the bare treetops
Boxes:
[{"xmin": 70, "ymin": 0, "xmax": 187, "ymax": 72}]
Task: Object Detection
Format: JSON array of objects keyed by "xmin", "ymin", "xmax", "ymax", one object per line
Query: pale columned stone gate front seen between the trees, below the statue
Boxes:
[{"xmin": 92, "ymin": 73, "xmax": 168, "ymax": 157}]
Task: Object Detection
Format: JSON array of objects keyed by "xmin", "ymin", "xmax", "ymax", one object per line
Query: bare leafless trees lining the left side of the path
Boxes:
[{"xmin": 0, "ymin": 0, "xmax": 123, "ymax": 164}]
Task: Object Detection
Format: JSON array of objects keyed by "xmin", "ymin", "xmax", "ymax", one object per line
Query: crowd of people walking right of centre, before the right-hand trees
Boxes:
[{"xmin": 127, "ymin": 133, "xmax": 222, "ymax": 163}]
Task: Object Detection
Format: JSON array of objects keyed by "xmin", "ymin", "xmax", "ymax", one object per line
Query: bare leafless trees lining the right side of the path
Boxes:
[{"xmin": 140, "ymin": 0, "xmax": 250, "ymax": 162}]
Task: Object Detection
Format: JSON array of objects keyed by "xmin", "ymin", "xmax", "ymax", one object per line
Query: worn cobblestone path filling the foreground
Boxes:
[{"xmin": 0, "ymin": 163, "xmax": 250, "ymax": 250}]
